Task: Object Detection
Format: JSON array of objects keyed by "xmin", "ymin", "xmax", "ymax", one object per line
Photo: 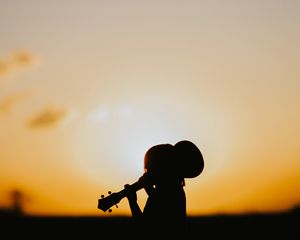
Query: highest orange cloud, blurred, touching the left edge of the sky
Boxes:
[{"xmin": 0, "ymin": 50, "xmax": 41, "ymax": 77}]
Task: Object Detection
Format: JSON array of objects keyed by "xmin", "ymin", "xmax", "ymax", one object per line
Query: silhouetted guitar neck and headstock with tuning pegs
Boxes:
[{"xmin": 98, "ymin": 178, "xmax": 144, "ymax": 212}]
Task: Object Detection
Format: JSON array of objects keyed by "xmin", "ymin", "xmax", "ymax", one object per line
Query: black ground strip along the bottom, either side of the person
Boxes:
[{"xmin": 0, "ymin": 210, "xmax": 300, "ymax": 240}]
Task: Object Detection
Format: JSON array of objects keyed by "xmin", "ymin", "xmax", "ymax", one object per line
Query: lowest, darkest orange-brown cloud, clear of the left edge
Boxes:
[{"xmin": 28, "ymin": 106, "xmax": 75, "ymax": 128}]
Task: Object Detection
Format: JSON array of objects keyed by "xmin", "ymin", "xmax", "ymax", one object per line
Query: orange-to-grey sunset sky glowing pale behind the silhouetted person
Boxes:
[{"xmin": 0, "ymin": 0, "xmax": 300, "ymax": 216}]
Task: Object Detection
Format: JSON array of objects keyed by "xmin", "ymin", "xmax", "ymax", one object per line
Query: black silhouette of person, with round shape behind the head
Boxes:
[{"xmin": 124, "ymin": 140, "xmax": 204, "ymax": 239}]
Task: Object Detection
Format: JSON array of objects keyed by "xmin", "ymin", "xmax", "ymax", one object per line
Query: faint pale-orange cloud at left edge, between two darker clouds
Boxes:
[{"xmin": 0, "ymin": 91, "xmax": 35, "ymax": 116}]
